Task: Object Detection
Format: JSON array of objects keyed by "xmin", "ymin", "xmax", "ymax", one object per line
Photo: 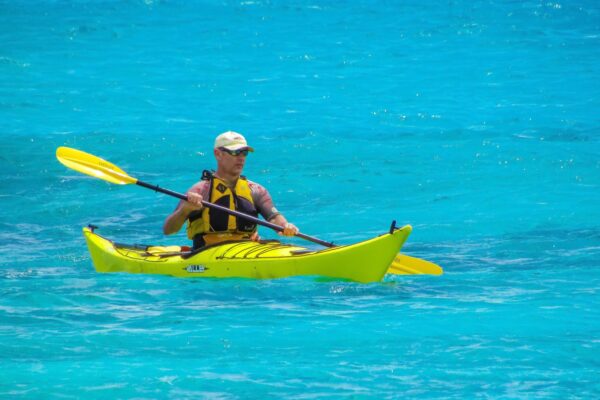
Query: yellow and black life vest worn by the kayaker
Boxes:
[{"xmin": 187, "ymin": 171, "xmax": 258, "ymax": 247}]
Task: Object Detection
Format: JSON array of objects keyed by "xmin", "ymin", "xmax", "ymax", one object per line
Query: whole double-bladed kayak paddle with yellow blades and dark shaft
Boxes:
[{"xmin": 56, "ymin": 147, "xmax": 441, "ymax": 275}]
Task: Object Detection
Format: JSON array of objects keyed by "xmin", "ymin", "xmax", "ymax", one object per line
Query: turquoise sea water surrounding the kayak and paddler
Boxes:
[{"xmin": 0, "ymin": 1, "xmax": 600, "ymax": 399}]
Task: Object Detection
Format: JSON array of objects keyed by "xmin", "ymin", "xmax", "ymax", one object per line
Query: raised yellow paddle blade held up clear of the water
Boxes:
[{"xmin": 56, "ymin": 147, "xmax": 137, "ymax": 185}]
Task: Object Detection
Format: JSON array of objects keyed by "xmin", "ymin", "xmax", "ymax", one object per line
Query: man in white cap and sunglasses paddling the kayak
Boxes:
[{"xmin": 163, "ymin": 131, "xmax": 298, "ymax": 249}]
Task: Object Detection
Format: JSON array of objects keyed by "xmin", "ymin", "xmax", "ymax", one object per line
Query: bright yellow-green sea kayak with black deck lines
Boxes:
[{"xmin": 83, "ymin": 225, "xmax": 412, "ymax": 283}]
